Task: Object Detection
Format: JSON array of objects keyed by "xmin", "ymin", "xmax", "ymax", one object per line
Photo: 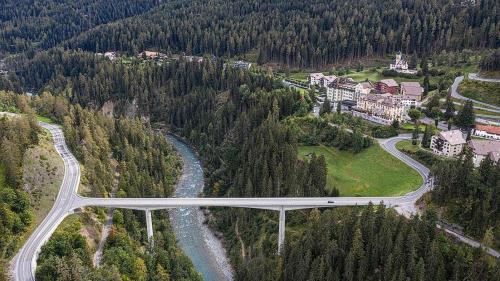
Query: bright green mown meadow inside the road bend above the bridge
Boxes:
[{"xmin": 299, "ymin": 144, "xmax": 422, "ymax": 196}]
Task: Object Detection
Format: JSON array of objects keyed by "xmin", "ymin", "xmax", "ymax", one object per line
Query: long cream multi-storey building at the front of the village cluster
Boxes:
[{"xmin": 355, "ymin": 94, "xmax": 405, "ymax": 124}]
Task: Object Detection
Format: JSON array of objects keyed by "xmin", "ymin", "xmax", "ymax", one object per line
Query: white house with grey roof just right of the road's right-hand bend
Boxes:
[{"xmin": 431, "ymin": 130, "xmax": 465, "ymax": 157}]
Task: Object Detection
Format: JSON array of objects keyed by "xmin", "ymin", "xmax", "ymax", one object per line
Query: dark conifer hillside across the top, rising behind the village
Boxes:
[{"xmin": 64, "ymin": 0, "xmax": 500, "ymax": 67}]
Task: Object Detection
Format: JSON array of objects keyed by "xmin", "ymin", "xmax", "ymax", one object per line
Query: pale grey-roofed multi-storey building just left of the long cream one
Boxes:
[{"xmin": 326, "ymin": 77, "xmax": 363, "ymax": 105}]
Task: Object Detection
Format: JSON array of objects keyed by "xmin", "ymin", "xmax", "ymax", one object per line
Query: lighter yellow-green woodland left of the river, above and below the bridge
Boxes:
[{"xmin": 0, "ymin": 93, "xmax": 200, "ymax": 281}]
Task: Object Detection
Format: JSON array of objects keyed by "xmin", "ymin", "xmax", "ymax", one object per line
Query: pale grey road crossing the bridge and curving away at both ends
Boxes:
[{"xmin": 12, "ymin": 122, "xmax": 498, "ymax": 281}]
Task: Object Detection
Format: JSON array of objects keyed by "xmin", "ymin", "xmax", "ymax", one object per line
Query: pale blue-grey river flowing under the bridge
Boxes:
[{"xmin": 166, "ymin": 135, "xmax": 233, "ymax": 281}]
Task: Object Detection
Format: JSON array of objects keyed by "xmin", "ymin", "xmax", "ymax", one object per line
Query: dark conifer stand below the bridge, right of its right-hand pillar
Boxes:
[{"xmin": 237, "ymin": 206, "xmax": 500, "ymax": 281}]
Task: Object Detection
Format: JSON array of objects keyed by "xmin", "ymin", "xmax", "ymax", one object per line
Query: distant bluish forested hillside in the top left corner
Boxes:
[{"xmin": 0, "ymin": 0, "xmax": 160, "ymax": 54}]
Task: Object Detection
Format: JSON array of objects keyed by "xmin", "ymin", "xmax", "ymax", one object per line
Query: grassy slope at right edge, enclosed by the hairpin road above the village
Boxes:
[{"xmin": 458, "ymin": 79, "xmax": 500, "ymax": 106}]
